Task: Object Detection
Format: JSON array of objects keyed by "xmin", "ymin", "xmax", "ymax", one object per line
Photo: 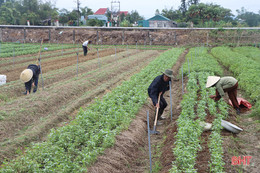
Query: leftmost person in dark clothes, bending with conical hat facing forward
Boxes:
[{"xmin": 20, "ymin": 64, "xmax": 40, "ymax": 95}]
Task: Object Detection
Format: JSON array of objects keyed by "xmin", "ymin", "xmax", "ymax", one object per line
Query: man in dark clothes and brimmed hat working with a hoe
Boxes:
[{"xmin": 148, "ymin": 69, "xmax": 173, "ymax": 120}]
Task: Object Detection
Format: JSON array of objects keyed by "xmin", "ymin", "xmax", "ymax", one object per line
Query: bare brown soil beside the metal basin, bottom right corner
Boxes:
[{"xmin": 221, "ymin": 94, "xmax": 260, "ymax": 173}]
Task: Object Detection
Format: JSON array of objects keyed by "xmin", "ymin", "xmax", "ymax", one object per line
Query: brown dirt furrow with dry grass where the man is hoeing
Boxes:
[{"xmin": 88, "ymin": 50, "xmax": 188, "ymax": 173}]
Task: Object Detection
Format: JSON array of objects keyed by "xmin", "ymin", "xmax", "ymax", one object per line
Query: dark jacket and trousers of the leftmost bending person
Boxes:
[{"xmin": 25, "ymin": 64, "xmax": 41, "ymax": 92}]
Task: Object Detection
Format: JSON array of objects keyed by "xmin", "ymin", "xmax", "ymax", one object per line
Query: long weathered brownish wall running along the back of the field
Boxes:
[{"xmin": 0, "ymin": 25, "xmax": 260, "ymax": 46}]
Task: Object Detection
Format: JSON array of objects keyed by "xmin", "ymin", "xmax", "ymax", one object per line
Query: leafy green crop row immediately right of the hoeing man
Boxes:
[{"xmin": 171, "ymin": 73, "xmax": 203, "ymax": 172}]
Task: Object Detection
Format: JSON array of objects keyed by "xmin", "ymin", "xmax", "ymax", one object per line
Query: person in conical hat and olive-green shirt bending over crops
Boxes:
[{"xmin": 206, "ymin": 76, "xmax": 240, "ymax": 115}]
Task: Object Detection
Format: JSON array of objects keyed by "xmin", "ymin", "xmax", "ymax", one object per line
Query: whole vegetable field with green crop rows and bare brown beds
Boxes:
[{"xmin": 0, "ymin": 43, "xmax": 260, "ymax": 173}]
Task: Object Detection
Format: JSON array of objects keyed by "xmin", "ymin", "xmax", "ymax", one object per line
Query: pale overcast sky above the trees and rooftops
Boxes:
[{"xmin": 53, "ymin": 0, "xmax": 260, "ymax": 19}]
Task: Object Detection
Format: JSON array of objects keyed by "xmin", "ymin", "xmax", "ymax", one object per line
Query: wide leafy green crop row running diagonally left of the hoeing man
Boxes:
[{"xmin": 1, "ymin": 49, "xmax": 183, "ymax": 172}]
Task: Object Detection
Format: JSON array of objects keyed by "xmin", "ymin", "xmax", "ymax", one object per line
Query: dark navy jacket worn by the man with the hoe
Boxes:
[{"xmin": 148, "ymin": 75, "xmax": 170, "ymax": 106}]
